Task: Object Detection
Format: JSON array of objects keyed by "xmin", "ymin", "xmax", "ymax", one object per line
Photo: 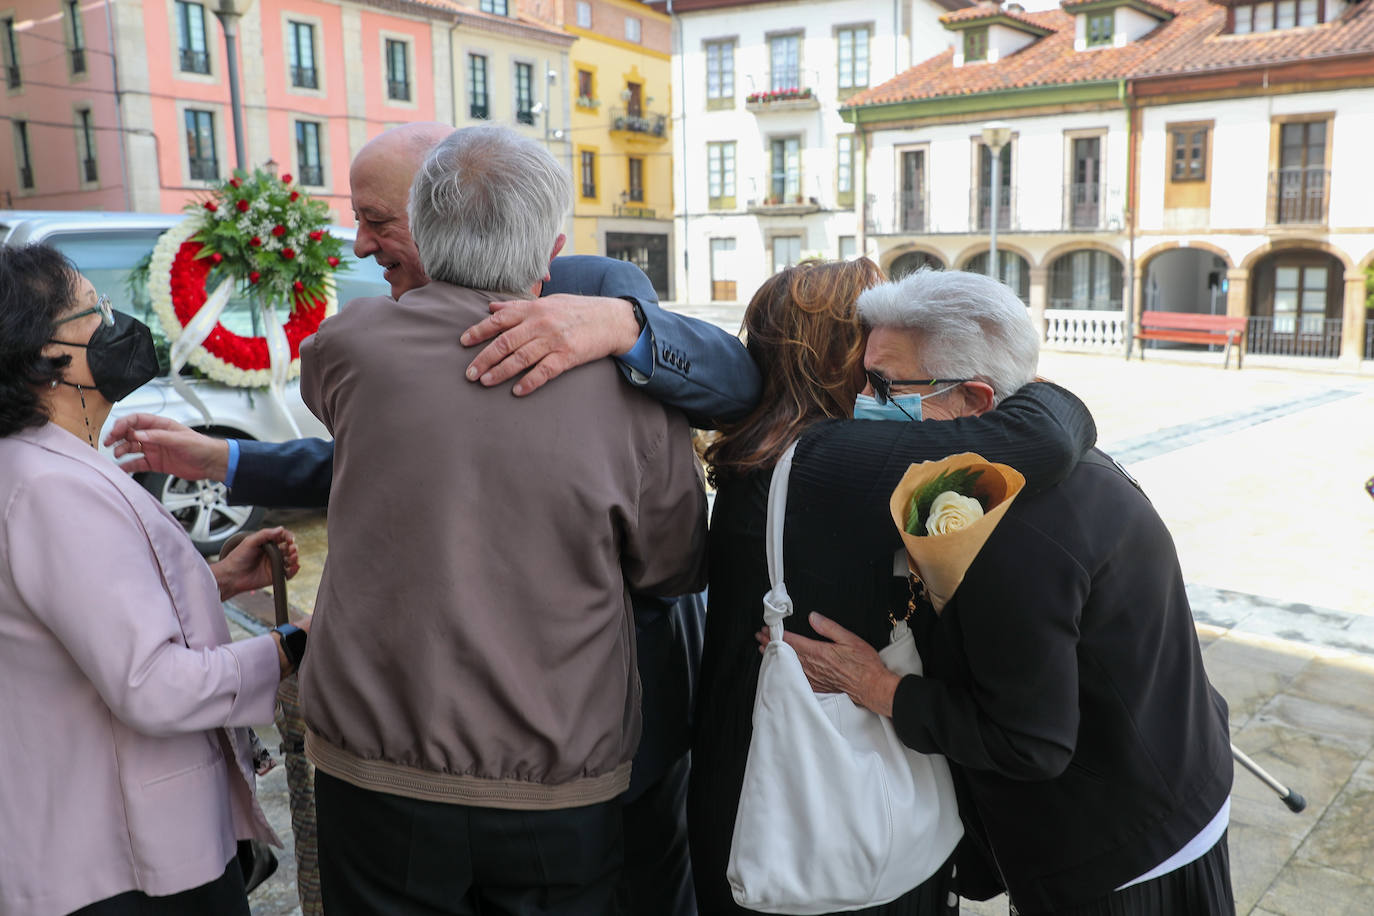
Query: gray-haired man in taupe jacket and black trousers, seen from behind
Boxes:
[{"xmin": 301, "ymin": 126, "xmax": 706, "ymax": 916}]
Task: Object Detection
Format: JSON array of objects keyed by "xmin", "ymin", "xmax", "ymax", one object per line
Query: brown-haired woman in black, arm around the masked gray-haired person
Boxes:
[{"xmin": 687, "ymin": 258, "xmax": 1095, "ymax": 916}]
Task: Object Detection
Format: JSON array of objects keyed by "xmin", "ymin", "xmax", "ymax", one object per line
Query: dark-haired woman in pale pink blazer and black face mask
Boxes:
[{"xmin": 0, "ymin": 246, "xmax": 306, "ymax": 916}]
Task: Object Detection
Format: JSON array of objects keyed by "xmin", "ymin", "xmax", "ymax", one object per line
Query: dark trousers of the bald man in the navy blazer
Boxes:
[{"xmin": 622, "ymin": 755, "xmax": 697, "ymax": 916}]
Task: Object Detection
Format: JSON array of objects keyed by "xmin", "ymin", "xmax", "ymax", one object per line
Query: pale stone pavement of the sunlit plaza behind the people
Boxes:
[{"xmin": 230, "ymin": 340, "xmax": 1374, "ymax": 916}]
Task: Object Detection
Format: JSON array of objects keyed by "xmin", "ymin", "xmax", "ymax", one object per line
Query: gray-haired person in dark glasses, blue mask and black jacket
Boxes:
[{"xmin": 786, "ymin": 271, "xmax": 1235, "ymax": 916}]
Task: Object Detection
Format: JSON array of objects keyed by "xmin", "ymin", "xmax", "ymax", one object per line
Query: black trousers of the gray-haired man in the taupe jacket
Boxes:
[{"xmin": 315, "ymin": 770, "xmax": 624, "ymax": 916}]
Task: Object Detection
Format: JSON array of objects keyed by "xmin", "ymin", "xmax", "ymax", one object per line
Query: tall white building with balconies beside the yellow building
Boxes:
[{"xmin": 671, "ymin": 0, "xmax": 966, "ymax": 302}]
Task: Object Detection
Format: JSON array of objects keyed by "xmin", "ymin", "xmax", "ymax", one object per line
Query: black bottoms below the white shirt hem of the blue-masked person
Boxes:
[{"xmin": 1011, "ymin": 834, "xmax": 1235, "ymax": 916}]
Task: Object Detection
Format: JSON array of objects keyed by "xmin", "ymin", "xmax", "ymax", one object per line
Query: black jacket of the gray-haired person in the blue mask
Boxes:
[{"xmin": 893, "ymin": 460, "xmax": 1231, "ymax": 913}]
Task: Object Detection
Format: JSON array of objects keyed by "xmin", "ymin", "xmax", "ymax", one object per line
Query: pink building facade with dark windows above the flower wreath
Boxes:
[{"xmin": 0, "ymin": 0, "xmax": 570, "ymax": 225}]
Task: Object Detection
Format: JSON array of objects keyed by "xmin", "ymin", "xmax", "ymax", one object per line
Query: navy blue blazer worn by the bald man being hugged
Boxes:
[{"xmin": 229, "ymin": 255, "xmax": 763, "ymax": 801}]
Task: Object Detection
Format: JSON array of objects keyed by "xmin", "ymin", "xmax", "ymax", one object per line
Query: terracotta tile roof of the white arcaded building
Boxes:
[{"xmin": 845, "ymin": 0, "xmax": 1374, "ymax": 107}]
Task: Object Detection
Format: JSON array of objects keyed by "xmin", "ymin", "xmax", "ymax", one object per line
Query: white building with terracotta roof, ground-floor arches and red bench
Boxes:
[{"xmin": 844, "ymin": 0, "xmax": 1374, "ymax": 369}]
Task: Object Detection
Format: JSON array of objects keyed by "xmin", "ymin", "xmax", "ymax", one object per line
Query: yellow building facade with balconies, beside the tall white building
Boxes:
[{"xmin": 563, "ymin": 0, "xmax": 675, "ymax": 299}]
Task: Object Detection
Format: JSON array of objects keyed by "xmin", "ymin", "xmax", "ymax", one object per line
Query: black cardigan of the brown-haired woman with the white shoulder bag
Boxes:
[{"xmin": 688, "ymin": 383, "xmax": 1096, "ymax": 916}]
